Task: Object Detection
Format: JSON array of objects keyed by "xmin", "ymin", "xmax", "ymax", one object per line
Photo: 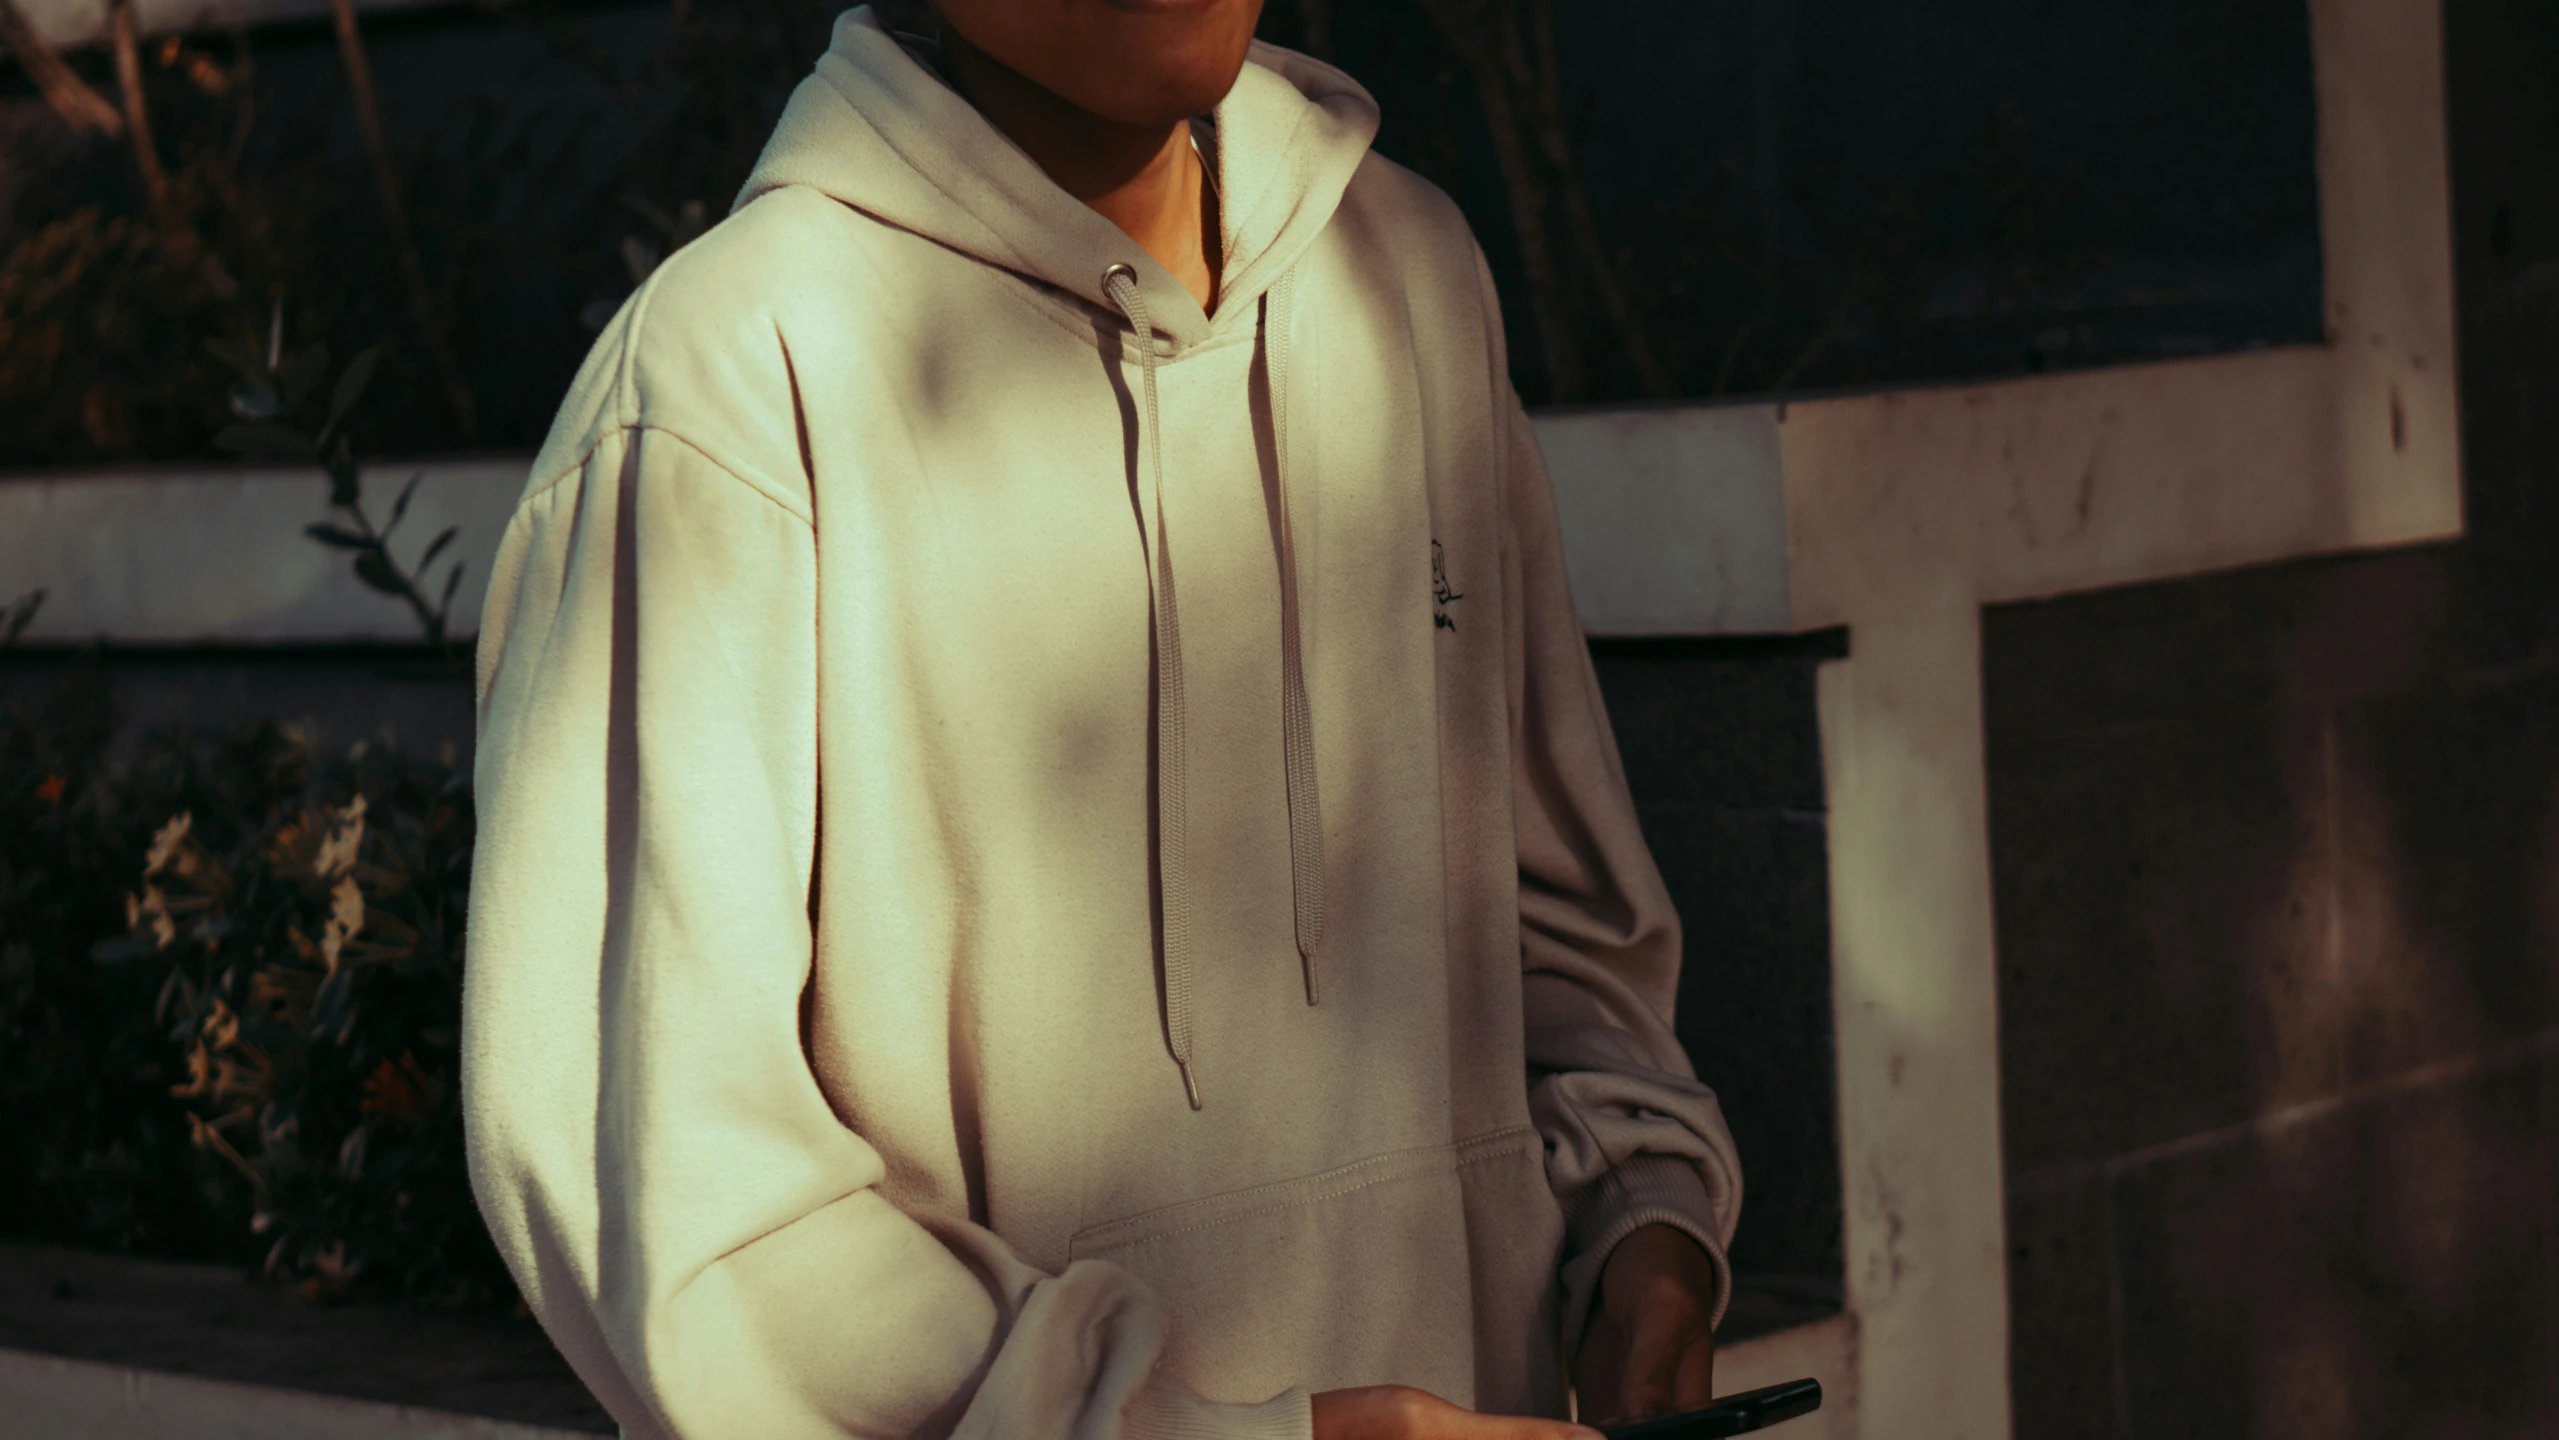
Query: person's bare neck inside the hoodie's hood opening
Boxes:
[{"xmin": 942, "ymin": 28, "xmax": 1221, "ymax": 309}]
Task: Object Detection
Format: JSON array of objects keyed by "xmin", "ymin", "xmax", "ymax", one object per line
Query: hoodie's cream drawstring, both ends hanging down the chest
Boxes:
[{"xmin": 1103, "ymin": 263, "xmax": 1326, "ymax": 1110}]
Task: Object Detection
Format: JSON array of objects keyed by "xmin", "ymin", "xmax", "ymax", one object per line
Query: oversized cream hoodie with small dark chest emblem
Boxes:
[{"xmin": 463, "ymin": 10, "xmax": 1740, "ymax": 1440}]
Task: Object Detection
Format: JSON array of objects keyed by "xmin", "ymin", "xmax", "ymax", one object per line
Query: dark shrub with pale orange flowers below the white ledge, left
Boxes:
[{"xmin": 0, "ymin": 683, "xmax": 514, "ymax": 1304}]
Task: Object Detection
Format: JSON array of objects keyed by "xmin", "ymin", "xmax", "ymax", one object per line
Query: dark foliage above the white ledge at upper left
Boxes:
[{"xmin": 0, "ymin": 0, "xmax": 834, "ymax": 466}]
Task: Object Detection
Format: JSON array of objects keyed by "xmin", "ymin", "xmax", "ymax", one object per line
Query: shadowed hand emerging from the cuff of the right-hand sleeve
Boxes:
[{"xmin": 1555, "ymin": 1225, "xmax": 1715, "ymax": 1435}]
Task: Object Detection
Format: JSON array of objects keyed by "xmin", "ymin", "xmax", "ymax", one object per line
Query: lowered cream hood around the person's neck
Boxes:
[{"xmin": 737, "ymin": 5, "xmax": 1377, "ymax": 356}]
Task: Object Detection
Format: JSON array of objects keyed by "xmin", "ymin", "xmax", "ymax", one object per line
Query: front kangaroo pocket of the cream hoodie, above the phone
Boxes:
[{"xmin": 1070, "ymin": 1128, "xmax": 1561, "ymax": 1404}]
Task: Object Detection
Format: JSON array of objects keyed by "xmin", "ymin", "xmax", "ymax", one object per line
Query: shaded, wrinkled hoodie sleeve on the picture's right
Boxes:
[{"xmin": 1497, "ymin": 304, "xmax": 1743, "ymax": 1353}]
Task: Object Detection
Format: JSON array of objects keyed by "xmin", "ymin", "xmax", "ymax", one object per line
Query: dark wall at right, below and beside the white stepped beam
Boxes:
[{"xmin": 1983, "ymin": 0, "xmax": 2559, "ymax": 1440}]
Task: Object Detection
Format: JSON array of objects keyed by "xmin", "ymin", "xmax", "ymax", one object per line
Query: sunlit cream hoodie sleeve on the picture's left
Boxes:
[{"xmin": 463, "ymin": 425, "xmax": 1308, "ymax": 1440}]
